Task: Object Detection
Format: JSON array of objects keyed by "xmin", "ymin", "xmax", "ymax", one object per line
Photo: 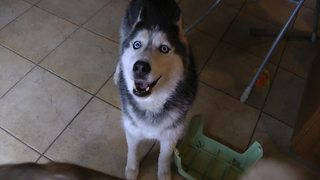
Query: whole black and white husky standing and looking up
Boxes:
[{"xmin": 114, "ymin": 0, "xmax": 197, "ymax": 179}]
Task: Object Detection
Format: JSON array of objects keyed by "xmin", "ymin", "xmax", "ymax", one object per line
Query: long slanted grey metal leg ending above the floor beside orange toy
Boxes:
[{"xmin": 240, "ymin": 0, "xmax": 304, "ymax": 102}]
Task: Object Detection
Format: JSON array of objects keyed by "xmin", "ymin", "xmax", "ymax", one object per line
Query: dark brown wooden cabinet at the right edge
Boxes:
[{"xmin": 292, "ymin": 57, "xmax": 320, "ymax": 165}]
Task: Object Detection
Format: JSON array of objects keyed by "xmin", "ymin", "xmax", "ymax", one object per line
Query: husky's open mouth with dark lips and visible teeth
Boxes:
[{"xmin": 133, "ymin": 76, "xmax": 161, "ymax": 97}]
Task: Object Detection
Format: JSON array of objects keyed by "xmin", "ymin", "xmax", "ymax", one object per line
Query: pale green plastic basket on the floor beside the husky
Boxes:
[{"xmin": 174, "ymin": 115, "xmax": 263, "ymax": 180}]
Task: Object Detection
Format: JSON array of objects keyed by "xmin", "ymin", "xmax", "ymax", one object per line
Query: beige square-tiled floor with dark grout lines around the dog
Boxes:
[{"xmin": 0, "ymin": 0, "xmax": 320, "ymax": 179}]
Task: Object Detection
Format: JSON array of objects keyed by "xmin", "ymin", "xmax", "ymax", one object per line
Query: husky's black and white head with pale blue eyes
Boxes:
[{"xmin": 120, "ymin": 0, "xmax": 188, "ymax": 100}]
